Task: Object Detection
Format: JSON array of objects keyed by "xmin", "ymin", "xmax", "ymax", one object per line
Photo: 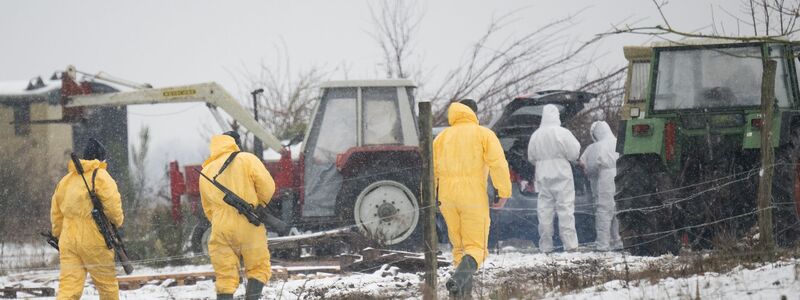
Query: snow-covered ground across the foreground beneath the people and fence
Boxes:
[{"xmin": 0, "ymin": 252, "xmax": 800, "ymax": 299}]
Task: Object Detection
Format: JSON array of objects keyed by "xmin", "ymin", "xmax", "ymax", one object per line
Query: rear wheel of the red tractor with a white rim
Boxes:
[{"xmin": 337, "ymin": 170, "xmax": 422, "ymax": 250}]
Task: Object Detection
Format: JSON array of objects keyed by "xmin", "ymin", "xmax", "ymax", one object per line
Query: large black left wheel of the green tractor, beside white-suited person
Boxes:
[{"xmin": 615, "ymin": 156, "xmax": 680, "ymax": 255}]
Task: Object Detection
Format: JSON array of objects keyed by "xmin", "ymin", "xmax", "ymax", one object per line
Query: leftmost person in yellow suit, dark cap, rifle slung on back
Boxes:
[{"xmin": 50, "ymin": 138, "xmax": 123, "ymax": 300}]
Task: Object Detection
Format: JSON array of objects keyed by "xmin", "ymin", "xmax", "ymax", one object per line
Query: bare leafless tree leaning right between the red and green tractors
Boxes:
[{"xmin": 430, "ymin": 12, "xmax": 616, "ymax": 123}]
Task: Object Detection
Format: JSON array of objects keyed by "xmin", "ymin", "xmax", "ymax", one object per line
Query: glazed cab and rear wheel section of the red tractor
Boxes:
[{"xmin": 299, "ymin": 80, "xmax": 419, "ymax": 244}]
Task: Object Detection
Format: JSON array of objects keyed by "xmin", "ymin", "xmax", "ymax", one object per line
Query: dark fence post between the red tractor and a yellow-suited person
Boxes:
[{"xmin": 419, "ymin": 102, "xmax": 438, "ymax": 299}]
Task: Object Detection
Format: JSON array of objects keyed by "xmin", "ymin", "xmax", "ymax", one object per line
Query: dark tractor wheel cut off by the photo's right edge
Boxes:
[{"xmin": 772, "ymin": 126, "xmax": 800, "ymax": 246}]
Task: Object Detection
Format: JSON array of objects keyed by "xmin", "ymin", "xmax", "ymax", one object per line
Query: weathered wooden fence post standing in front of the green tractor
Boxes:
[{"xmin": 758, "ymin": 58, "xmax": 777, "ymax": 256}]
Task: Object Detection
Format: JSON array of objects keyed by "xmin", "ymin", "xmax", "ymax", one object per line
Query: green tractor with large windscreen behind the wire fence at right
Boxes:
[{"xmin": 616, "ymin": 40, "xmax": 800, "ymax": 255}]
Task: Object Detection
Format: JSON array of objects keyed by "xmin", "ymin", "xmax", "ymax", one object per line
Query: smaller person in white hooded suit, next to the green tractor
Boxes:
[{"xmin": 580, "ymin": 121, "xmax": 622, "ymax": 251}]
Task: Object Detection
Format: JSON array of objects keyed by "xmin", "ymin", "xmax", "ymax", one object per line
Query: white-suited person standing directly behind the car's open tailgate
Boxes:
[{"xmin": 528, "ymin": 104, "xmax": 581, "ymax": 252}]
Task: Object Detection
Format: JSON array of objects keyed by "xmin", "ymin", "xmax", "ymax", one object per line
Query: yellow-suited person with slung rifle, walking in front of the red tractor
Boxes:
[{"xmin": 200, "ymin": 131, "xmax": 275, "ymax": 299}]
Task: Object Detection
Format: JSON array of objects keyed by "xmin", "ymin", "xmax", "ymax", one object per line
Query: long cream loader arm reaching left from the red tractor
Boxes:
[{"xmin": 64, "ymin": 82, "xmax": 283, "ymax": 153}]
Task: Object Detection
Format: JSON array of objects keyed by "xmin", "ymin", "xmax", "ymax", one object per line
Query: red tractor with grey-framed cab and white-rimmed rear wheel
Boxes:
[{"xmin": 164, "ymin": 80, "xmax": 421, "ymax": 252}]
